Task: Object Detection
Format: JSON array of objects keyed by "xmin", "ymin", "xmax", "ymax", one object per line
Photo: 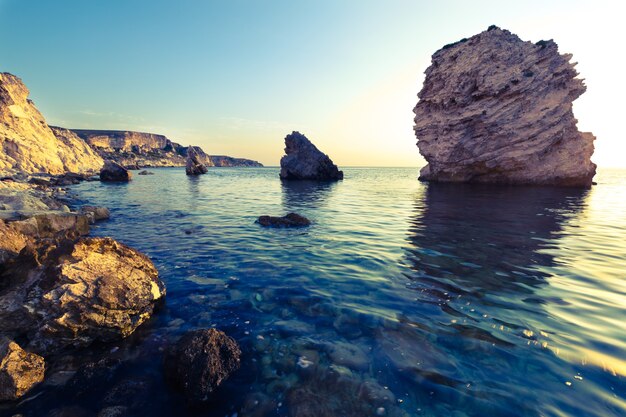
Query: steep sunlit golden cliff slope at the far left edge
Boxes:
[{"xmin": 0, "ymin": 72, "xmax": 103, "ymax": 175}]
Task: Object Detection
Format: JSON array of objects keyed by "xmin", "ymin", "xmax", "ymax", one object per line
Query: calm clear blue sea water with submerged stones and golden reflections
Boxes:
[{"xmin": 0, "ymin": 168, "xmax": 626, "ymax": 417}]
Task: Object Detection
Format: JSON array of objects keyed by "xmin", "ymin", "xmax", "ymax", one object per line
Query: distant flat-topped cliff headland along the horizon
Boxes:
[{"xmin": 72, "ymin": 129, "xmax": 263, "ymax": 169}]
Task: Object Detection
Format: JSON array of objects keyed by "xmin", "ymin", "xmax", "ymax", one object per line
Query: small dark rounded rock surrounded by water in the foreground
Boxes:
[{"xmin": 165, "ymin": 329, "xmax": 241, "ymax": 403}]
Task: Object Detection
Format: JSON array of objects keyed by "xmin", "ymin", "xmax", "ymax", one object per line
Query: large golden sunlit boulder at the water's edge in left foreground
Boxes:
[{"xmin": 0, "ymin": 238, "xmax": 165, "ymax": 353}]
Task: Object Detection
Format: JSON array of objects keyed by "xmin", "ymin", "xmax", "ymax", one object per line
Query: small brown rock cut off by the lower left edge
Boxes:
[{"xmin": 0, "ymin": 337, "xmax": 45, "ymax": 401}]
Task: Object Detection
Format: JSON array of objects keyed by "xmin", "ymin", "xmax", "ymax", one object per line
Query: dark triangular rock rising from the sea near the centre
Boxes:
[{"xmin": 280, "ymin": 132, "xmax": 343, "ymax": 181}]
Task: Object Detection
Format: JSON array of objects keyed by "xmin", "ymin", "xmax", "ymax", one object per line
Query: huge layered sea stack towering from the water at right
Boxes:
[{"xmin": 413, "ymin": 26, "xmax": 596, "ymax": 187}]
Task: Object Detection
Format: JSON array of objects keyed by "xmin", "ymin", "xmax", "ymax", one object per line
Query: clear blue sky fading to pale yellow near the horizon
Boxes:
[{"xmin": 0, "ymin": 0, "xmax": 626, "ymax": 167}]
